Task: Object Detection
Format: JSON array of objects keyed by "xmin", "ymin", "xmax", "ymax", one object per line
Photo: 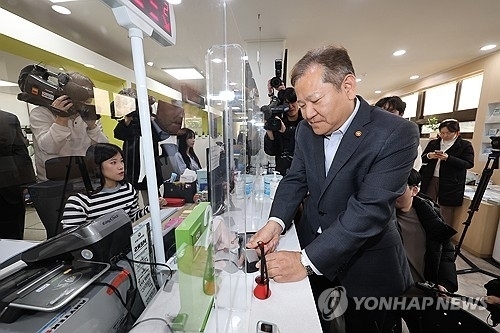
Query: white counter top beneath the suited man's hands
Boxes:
[{"xmin": 130, "ymin": 198, "xmax": 321, "ymax": 333}]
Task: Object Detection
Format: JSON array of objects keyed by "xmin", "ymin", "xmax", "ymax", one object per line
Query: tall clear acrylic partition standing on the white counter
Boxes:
[{"xmin": 206, "ymin": 44, "xmax": 252, "ymax": 333}]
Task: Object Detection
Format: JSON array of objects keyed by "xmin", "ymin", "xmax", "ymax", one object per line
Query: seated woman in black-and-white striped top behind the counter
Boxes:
[{"xmin": 61, "ymin": 143, "xmax": 166, "ymax": 229}]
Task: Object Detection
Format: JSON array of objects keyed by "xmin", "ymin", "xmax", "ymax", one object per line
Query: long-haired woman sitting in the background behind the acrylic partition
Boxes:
[{"xmin": 174, "ymin": 128, "xmax": 201, "ymax": 176}]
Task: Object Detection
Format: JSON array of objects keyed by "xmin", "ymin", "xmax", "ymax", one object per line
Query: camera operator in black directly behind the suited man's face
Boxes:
[{"xmin": 264, "ymin": 80, "xmax": 303, "ymax": 176}]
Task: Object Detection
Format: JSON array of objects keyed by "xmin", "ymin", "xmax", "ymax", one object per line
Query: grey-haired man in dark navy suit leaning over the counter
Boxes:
[{"xmin": 247, "ymin": 46, "xmax": 419, "ymax": 332}]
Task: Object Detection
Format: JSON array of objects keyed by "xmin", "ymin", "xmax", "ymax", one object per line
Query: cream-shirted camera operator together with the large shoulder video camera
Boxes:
[{"xmin": 21, "ymin": 65, "xmax": 108, "ymax": 181}]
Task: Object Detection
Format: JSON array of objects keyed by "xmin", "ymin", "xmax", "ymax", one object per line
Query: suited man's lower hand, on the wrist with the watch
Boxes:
[{"xmin": 266, "ymin": 251, "xmax": 307, "ymax": 282}]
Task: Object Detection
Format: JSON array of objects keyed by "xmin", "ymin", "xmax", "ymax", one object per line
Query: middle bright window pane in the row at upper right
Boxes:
[{"xmin": 424, "ymin": 81, "xmax": 457, "ymax": 116}]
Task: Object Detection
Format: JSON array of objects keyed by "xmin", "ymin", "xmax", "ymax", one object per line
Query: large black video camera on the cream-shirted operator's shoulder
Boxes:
[{"xmin": 17, "ymin": 65, "xmax": 100, "ymax": 120}]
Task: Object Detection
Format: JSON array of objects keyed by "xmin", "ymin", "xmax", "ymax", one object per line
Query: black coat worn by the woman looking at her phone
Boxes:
[{"xmin": 420, "ymin": 135, "xmax": 474, "ymax": 206}]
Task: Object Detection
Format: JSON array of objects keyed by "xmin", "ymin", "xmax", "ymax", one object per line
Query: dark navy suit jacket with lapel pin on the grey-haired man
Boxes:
[{"xmin": 270, "ymin": 96, "xmax": 419, "ymax": 297}]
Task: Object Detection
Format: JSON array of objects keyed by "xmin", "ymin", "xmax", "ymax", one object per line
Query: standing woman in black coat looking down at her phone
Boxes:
[{"xmin": 420, "ymin": 119, "xmax": 474, "ymax": 225}]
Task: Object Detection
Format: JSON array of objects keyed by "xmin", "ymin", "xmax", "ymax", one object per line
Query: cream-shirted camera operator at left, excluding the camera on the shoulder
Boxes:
[{"xmin": 29, "ymin": 72, "xmax": 108, "ymax": 181}]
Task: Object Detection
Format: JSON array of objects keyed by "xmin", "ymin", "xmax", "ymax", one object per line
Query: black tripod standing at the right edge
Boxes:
[{"xmin": 455, "ymin": 149, "xmax": 500, "ymax": 278}]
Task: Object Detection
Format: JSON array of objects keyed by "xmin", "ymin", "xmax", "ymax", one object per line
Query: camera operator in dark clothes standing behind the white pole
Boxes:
[{"xmin": 111, "ymin": 88, "xmax": 165, "ymax": 201}]
